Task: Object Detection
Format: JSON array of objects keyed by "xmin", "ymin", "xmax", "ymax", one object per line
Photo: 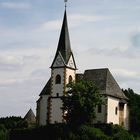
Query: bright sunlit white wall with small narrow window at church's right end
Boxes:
[{"xmin": 107, "ymin": 97, "xmax": 119, "ymax": 124}]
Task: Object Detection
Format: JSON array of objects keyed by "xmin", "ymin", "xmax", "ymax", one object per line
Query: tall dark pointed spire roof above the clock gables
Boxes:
[{"xmin": 51, "ymin": 10, "xmax": 72, "ymax": 67}]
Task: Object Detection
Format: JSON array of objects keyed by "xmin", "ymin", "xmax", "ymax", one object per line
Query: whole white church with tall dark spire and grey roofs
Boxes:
[{"xmin": 36, "ymin": 9, "xmax": 129, "ymax": 129}]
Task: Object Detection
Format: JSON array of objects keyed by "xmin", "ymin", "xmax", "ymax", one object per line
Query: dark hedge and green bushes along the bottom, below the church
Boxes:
[{"xmin": 10, "ymin": 124, "xmax": 140, "ymax": 140}]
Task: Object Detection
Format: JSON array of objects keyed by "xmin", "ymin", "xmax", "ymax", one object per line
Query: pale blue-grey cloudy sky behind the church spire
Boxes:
[{"xmin": 0, "ymin": 0, "xmax": 140, "ymax": 117}]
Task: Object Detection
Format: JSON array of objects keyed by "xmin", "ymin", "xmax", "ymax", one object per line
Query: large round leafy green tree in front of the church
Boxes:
[{"xmin": 62, "ymin": 81, "xmax": 103, "ymax": 126}]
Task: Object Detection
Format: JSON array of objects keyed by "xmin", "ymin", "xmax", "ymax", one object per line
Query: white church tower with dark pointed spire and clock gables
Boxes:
[{"xmin": 47, "ymin": 10, "xmax": 76, "ymax": 123}]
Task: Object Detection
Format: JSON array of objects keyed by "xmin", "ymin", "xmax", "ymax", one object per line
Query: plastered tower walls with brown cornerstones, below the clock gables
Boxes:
[{"xmin": 50, "ymin": 68, "xmax": 75, "ymax": 123}]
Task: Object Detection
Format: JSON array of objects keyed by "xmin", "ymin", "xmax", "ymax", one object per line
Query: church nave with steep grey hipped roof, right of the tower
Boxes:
[{"xmin": 76, "ymin": 68, "xmax": 129, "ymax": 129}]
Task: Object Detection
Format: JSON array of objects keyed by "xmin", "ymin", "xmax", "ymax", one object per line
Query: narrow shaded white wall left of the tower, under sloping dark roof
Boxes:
[{"xmin": 39, "ymin": 95, "xmax": 48, "ymax": 125}]
